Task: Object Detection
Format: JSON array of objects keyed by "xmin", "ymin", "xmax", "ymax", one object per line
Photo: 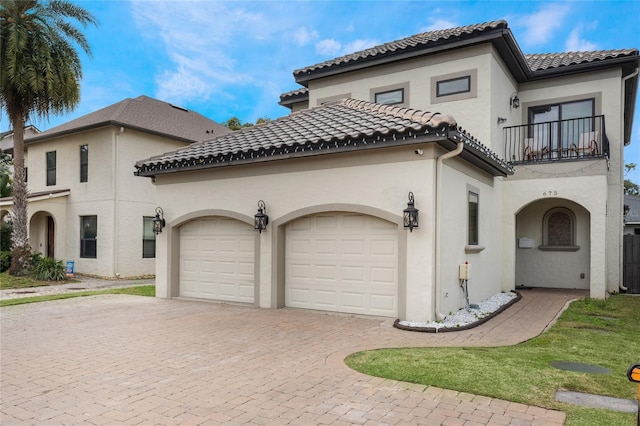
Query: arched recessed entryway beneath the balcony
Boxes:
[{"xmin": 516, "ymin": 198, "xmax": 591, "ymax": 289}]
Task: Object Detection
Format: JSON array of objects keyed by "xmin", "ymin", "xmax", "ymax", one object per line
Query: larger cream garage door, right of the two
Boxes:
[{"xmin": 285, "ymin": 213, "xmax": 398, "ymax": 317}]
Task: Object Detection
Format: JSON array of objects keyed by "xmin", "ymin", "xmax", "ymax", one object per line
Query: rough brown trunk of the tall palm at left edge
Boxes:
[{"xmin": 9, "ymin": 116, "xmax": 31, "ymax": 275}]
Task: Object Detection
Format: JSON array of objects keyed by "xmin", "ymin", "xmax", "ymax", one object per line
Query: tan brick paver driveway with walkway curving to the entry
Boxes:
[{"xmin": 0, "ymin": 290, "xmax": 585, "ymax": 426}]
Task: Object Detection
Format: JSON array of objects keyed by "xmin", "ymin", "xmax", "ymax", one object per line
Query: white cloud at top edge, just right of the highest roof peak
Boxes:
[{"xmin": 518, "ymin": 3, "xmax": 571, "ymax": 46}]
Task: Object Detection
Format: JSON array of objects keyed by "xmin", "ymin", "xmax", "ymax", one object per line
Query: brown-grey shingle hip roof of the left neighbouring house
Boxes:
[{"xmin": 26, "ymin": 96, "xmax": 231, "ymax": 143}]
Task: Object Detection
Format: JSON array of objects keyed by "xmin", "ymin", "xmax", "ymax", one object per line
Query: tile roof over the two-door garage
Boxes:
[{"xmin": 136, "ymin": 99, "xmax": 511, "ymax": 176}]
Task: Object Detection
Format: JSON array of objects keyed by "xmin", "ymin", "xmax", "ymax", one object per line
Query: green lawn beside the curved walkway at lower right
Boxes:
[{"xmin": 346, "ymin": 295, "xmax": 640, "ymax": 426}]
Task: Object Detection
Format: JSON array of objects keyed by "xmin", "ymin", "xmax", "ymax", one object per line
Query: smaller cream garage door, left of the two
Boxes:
[{"xmin": 180, "ymin": 217, "xmax": 256, "ymax": 303}]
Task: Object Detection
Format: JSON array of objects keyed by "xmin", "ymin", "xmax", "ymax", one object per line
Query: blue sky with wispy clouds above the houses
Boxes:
[{"xmin": 0, "ymin": 0, "xmax": 640, "ymax": 183}]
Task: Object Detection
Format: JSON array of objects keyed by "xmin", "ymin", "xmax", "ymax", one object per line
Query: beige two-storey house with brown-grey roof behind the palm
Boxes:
[{"xmin": 0, "ymin": 96, "xmax": 230, "ymax": 277}]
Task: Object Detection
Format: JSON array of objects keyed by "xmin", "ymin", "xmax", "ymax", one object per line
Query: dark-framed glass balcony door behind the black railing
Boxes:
[{"xmin": 529, "ymin": 99, "xmax": 595, "ymax": 158}]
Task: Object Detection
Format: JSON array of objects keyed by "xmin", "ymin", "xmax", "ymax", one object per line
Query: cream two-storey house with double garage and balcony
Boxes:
[{"xmin": 136, "ymin": 21, "xmax": 640, "ymax": 322}]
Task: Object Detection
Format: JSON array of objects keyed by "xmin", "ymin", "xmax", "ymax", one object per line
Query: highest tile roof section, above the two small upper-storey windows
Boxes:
[{"xmin": 293, "ymin": 20, "xmax": 507, "ymax": 79}]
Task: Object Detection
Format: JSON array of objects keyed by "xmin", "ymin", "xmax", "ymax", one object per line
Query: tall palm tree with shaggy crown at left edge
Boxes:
[{"xmin": 0, "ymin": 0, "xmax": 97, "ymax": 275}]
